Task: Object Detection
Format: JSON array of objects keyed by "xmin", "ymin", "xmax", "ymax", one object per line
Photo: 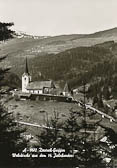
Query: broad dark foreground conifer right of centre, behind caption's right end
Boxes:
[{"xmin": 57, "ymin": 108, "xmax": 105, "ymax": 168}]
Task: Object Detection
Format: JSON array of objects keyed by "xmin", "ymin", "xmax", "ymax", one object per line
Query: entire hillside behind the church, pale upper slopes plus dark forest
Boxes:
[{"xmin": 0, "ymin": 28, "xmax": 117, "ymax": 96}]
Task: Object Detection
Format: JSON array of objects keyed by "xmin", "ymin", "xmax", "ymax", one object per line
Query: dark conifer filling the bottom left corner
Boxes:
[{"xmin": 0, "ymin": 105, "xmax": 27, "ymax": 168}]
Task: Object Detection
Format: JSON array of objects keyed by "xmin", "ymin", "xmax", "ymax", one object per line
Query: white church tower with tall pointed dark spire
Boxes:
[{"xmin": 22, "ymin": 58, "xmax": 31, "ymax": 93}]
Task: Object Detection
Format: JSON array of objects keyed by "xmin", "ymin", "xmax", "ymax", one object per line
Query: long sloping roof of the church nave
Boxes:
[{"xmin": 27, "ymin": 80, "xmax": 55, "ymax": 90}]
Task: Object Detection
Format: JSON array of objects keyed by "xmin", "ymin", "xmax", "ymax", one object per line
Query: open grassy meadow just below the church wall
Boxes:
[{"xmin": 7, "ymin": 99, "xmax": 79, "ymax": 121}]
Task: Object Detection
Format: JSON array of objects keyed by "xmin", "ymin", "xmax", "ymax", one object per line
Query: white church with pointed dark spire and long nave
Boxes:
[{"xmin": 22, "ymin": 58, "xmax": 56, "ymax": 95}]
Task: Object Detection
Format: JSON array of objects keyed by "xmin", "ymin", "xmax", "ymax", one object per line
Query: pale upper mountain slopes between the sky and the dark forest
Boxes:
[{"xmin": 0, "ymin": 28, "xmax": 117, "ymax": 57}]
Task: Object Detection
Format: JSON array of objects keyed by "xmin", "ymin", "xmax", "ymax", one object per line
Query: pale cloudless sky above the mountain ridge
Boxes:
[{"xmin": 0, "ymin": 0, "xmax": 117, "ymax": 36}]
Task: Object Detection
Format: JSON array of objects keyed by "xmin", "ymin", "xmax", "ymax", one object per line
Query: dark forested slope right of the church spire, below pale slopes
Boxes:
[{"xmin": 29, "ymin": 41, "xmax": 117, "ymax": 96}]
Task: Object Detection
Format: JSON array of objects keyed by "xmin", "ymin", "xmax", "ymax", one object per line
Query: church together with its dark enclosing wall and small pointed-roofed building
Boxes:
[{"xmin": 18, "ymin": 59, "xmax": 73, "ymax": 102}]
